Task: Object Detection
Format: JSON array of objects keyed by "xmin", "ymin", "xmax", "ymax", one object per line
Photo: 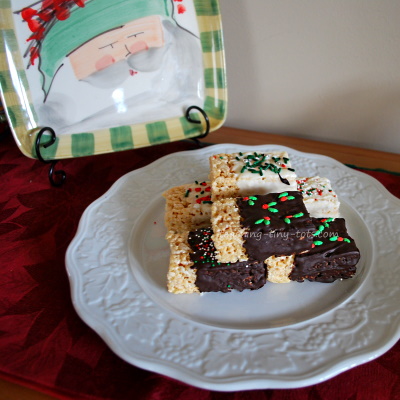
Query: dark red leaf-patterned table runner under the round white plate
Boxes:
[{"xmin": 0, "ymin": 129, "xmax": 400, "ymax": 400}]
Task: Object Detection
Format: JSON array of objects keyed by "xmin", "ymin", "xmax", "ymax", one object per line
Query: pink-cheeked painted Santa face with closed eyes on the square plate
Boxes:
[{"xmin": 68, "ymin": 15, "xmax": 165, "ymax": 80}]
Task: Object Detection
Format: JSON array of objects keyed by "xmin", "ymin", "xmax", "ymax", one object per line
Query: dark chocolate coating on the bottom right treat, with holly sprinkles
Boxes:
[{"xmin": 290, "ymin": 218, "xmax": 360, "ymax": 283}]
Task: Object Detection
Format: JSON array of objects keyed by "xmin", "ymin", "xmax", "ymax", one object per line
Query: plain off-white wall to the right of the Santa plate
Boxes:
[{"xmin": 219, "ymin": 0, "xmax": 400, "ymax": 153}]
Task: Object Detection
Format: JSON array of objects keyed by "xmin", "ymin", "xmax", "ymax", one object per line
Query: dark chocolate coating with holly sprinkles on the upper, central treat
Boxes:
[{"xmin": 236, "ymin": 191, "xmax": 316, "ymax": 260}]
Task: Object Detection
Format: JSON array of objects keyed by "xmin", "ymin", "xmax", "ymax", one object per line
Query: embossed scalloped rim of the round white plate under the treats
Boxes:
[{"xmin": 66, "ymin": 144, "xmax": 400, "ymax": 391}]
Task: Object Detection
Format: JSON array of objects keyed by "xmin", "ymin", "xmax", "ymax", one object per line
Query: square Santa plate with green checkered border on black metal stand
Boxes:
[{"xmin": 0, "ymin": 0, "xmax": 227, "ymax": 159}]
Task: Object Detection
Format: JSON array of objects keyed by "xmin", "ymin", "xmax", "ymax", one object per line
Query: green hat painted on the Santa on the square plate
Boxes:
[{"xmin": 33, "ymin": 0, "xmax": 173, "ymax": 96}]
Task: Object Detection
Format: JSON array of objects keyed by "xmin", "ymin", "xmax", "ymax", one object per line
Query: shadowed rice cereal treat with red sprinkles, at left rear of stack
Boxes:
[{"xmin": 163, "ymin": 181, "xmax": 211, "ymax": 232}]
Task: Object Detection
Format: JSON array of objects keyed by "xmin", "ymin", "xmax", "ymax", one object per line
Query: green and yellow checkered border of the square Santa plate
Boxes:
[{"xmin": 0, "ymin": 0, "xmax": 227, "ymax": 159}]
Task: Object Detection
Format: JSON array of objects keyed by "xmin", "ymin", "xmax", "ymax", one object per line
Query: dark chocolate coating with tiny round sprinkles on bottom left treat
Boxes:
[{"xmin": 188, "ymin": 228, "xmax": 266, "ymax": 292}]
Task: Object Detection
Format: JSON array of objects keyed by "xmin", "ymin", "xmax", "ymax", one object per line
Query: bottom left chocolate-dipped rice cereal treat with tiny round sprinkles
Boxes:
[{"xmin": 167, "ymin": 228, "xmax": 266, "ymax": 293}]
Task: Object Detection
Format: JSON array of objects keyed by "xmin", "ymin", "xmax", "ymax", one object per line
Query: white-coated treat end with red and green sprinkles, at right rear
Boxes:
[{"xmin": 297, "ymin": 176, "xmax": 340, "ymax": 218}]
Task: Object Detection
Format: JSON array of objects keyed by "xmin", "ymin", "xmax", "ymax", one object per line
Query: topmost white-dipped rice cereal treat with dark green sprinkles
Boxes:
[{"xmin": 210, "ymin": 151, "xmax": 297, "ymax": 201}]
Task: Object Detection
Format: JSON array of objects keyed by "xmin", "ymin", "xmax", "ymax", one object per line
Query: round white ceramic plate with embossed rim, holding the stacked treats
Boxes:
[{"xmin": 66, "ymin": 144, "xmax": 400, "ymax": 391}]
